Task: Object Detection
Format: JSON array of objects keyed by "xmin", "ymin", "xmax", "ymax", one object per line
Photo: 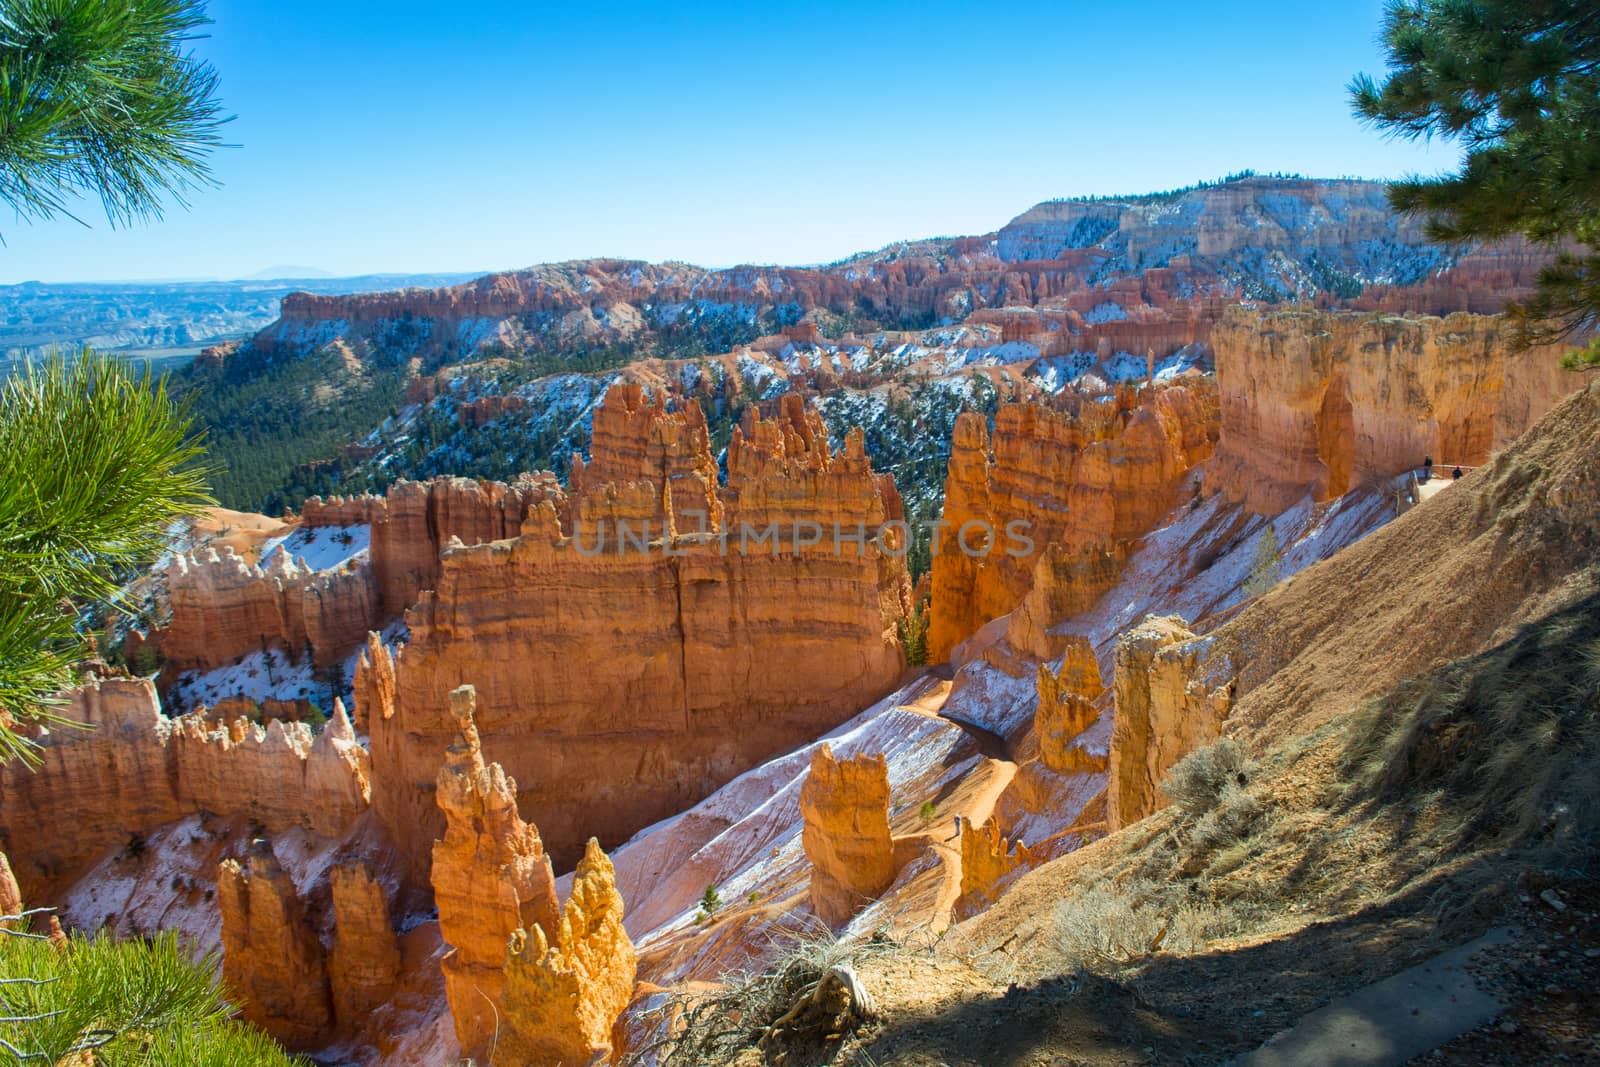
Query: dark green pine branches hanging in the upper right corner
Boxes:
[{"xmin": 1350, "ymin": 0, "xmax": 1600, "ymax": 365}]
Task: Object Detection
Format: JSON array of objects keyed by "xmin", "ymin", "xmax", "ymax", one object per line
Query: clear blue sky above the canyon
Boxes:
[{"xmin": 0, "ymin": 0, "xmax": 1454, "ymax": 282}]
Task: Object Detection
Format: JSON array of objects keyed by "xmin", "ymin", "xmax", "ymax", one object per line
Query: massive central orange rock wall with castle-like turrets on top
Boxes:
[{"xmin": 366, "ymin": 389, "xmax": 909, "ymax": 883}]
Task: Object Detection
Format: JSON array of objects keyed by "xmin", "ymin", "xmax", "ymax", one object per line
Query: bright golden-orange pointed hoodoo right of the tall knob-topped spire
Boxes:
[{"xmin": 493, "ymin": 838, "xmax": 638, "ymax": 1067}]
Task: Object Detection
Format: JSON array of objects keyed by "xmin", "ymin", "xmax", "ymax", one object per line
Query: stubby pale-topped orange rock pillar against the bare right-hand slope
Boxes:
[{"xmin": 1106, "ymin": 616, "xmax": 1234, "ymax": 830}]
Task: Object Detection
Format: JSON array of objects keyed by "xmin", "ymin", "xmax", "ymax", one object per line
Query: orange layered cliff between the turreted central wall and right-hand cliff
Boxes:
[{"xmin": 928, "ymin": 376, "xmax": 1218, "ymax": 661}]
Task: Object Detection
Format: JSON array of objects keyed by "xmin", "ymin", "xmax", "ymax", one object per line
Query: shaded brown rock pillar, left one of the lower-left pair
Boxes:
[{"xmin": 216, "ymin": 840, "xmax": 333, "ymax": 1049}]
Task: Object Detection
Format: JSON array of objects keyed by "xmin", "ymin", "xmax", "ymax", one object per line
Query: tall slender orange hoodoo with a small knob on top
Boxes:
[{"xmin": 432, "ymin": 686, "xmax": 558, "ymax": 1056}]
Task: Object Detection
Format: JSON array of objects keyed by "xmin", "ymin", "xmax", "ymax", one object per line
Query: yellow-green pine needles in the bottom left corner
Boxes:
[{"xmin": 0, "ymin": 929, "xmax": 304, "ymax": 1067}]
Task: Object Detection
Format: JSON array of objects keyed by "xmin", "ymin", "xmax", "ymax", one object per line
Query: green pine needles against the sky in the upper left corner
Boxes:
[{"xmin": 0, "ymin": 0, "xmax": 227, "ymax": 233}]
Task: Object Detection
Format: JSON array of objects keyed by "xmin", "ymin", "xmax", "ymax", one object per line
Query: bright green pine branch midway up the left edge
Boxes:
[{"xmin": 0, "ymin": 350, "xmax": 211, "ymax": 757}]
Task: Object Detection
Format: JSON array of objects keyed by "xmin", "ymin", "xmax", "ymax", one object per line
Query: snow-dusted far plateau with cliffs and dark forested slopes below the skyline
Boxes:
[{"xmin": 176, "ymin": 174, "xmax": 1544, "ymax": 515}]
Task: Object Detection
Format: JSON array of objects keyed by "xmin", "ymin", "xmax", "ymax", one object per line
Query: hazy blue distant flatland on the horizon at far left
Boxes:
[{"xmin": 0, "ymin": 267, "xmax": 474, "ymax": 365}]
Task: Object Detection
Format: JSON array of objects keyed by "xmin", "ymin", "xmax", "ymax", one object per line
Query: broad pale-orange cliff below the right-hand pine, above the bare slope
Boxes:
[{"xmin": 1206, "ymin": 309, "xmax": 1584, "ymax": 515}]
